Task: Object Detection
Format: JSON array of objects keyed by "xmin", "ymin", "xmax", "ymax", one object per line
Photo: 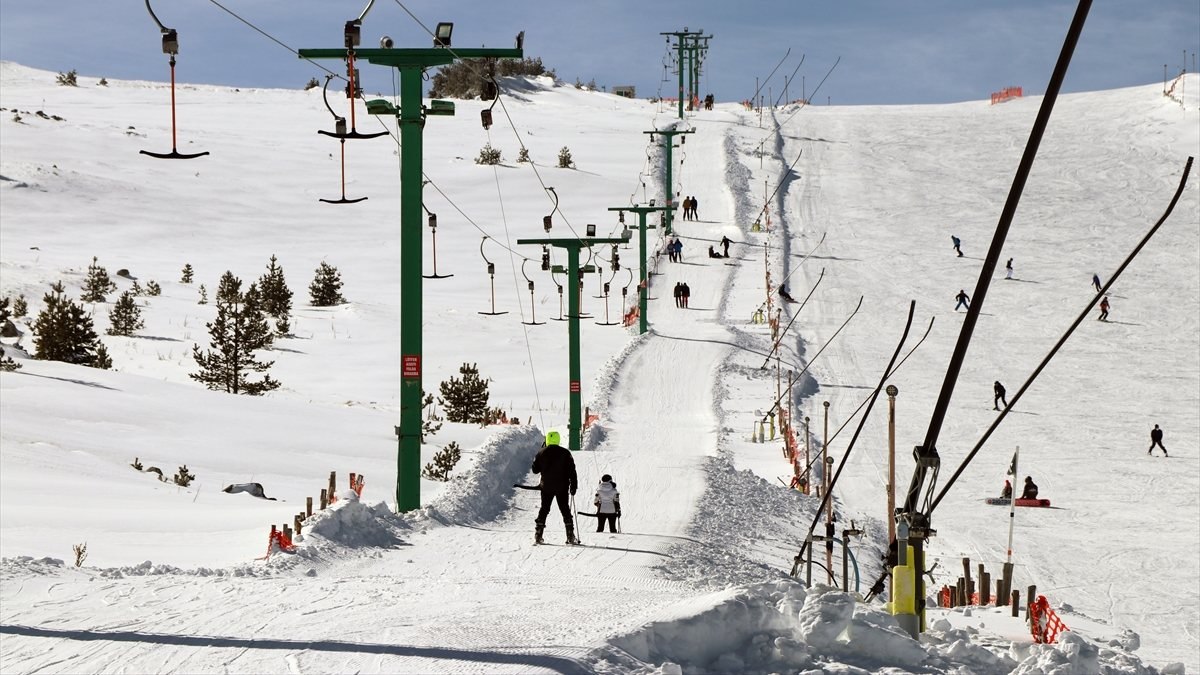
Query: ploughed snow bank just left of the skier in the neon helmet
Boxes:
[{"xmin": 418, "ymin": 425, "xmax": 542, "ymax": 525}]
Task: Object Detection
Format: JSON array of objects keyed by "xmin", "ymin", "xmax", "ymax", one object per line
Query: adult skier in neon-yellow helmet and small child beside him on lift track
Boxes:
[{"xmin": 533, "ymin": 431, "xmax": 620, "ymax": 544}]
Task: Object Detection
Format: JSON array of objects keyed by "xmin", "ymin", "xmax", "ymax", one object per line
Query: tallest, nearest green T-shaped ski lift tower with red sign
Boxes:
[{"xmin": 299, "ymin": 23, "xmax": 524, "ymax": 513}]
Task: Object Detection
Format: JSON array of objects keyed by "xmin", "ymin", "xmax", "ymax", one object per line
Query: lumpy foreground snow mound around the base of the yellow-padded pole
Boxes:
[{"xmin": 595, "ymin": 580, "xmax": 1161, "ymax": 675}]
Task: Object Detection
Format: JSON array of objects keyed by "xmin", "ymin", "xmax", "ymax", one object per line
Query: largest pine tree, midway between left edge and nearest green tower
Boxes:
[{"xmin": 190, "ymin": 274, "xmax": 280, "ymax": 396}]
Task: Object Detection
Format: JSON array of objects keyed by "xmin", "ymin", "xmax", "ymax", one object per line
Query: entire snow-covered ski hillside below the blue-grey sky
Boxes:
[{"xmin": 0, "ymin": 62, "xmax": 1200, "ymax": 674}]
